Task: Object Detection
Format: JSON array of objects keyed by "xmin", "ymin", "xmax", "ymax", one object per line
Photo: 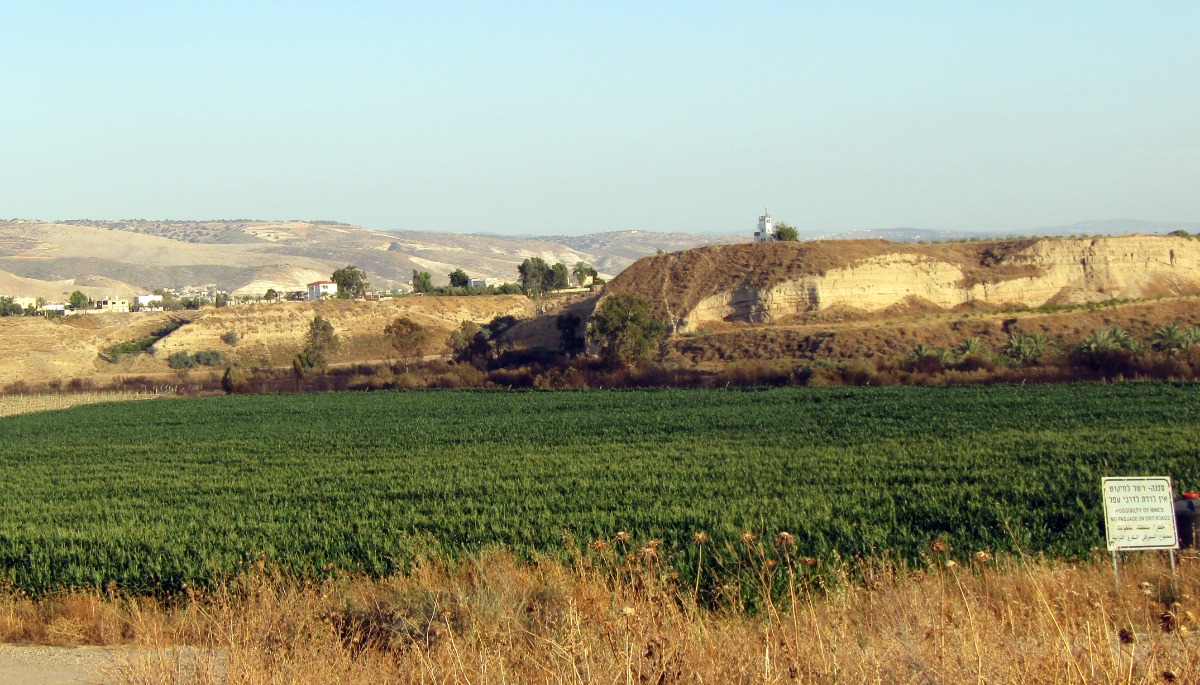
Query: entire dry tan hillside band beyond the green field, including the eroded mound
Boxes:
[{"xmin": 7, "ymin": 228, "xmax": 1200, "ymax": 387}]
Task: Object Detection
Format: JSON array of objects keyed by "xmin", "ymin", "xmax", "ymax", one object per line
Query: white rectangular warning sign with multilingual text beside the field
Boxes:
[{"xmin": 1100, "ymin": 476, "xmax": 1180, "ymax": 552}]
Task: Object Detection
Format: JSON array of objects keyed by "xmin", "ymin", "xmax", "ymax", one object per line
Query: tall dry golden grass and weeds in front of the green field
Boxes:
[{"xmin": 0, "ymin": 552, "xmax": 1200, "ymax": 685}]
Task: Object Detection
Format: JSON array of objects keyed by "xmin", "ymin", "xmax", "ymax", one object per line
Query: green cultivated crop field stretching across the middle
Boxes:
[{"xmin": 0, "ymin": 384, "xmax": 1200, "ymax": 591}]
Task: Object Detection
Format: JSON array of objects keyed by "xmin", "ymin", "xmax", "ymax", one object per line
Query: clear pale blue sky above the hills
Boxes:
[{"xmin": 0, "ymin": 0, "xmax": 1200, "ymax": 234}]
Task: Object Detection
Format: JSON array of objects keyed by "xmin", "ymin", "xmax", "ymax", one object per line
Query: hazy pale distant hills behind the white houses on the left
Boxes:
[{"xmin": 0, "ymin": 220, "xmax": 739, "ymax": 294}]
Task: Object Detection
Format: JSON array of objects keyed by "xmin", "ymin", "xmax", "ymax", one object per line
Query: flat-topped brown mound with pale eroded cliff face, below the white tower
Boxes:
[{"xmin": 610, "ymin": 235, "xmax": 1200, "ymax": 332}]
